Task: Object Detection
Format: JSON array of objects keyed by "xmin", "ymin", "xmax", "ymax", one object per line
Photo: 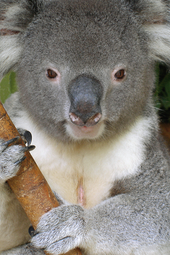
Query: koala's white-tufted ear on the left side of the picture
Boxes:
[{"xmin": 0, "ymin": 0, "xmax": 42, "ymax": 80}]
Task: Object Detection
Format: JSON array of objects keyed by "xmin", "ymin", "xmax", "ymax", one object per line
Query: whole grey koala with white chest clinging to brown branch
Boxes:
[{"xmin": 0, "ymin": 0, "xmax": 170, "ymax": 255}]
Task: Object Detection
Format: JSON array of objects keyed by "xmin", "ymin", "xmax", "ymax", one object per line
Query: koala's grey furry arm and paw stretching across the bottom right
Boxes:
[{"xmin": 32, "ymin": 152, "xmax": 170, "ymax": 255}]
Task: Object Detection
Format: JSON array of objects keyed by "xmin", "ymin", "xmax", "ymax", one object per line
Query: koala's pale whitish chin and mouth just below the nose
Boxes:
[{"xmin": 66, "ymin": 121, "xmax": 105, "ymax": 140}]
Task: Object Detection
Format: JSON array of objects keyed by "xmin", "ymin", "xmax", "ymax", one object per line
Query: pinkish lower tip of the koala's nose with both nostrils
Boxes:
[{"xmin": 69, "ymin": 112, "xmax": 102, "ymax": 127}]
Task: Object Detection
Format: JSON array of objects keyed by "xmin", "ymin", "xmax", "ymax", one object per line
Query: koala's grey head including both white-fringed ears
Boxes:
[{"xmin": 0, "ymin": 0, "xmax": 170, "ymax": 141}]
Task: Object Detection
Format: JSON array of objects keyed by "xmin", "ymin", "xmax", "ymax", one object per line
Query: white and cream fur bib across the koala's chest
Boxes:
[{"xmin": 15, "ymin": 116, "xmax": 150, "ymax": 208}]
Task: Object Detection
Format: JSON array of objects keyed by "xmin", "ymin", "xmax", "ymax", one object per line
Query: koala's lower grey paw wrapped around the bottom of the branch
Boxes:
[{"xmin": 32, "ymin": 205, "xmax": 85, "ymax": 255}]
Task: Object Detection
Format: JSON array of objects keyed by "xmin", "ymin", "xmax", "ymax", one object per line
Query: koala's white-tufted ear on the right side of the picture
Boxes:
[{"xmin": 127, "ymin": 0, "xmax": 170, "ymax": 64}]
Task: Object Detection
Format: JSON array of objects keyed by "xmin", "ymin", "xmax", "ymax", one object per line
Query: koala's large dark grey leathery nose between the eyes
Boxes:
[{"xmin": 68, "ymin": 74, "xmax": 103, "ymax": 126}]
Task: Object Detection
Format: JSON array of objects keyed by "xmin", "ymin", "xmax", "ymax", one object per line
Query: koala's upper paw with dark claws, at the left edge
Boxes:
[{"xmin": 0, "ymin": 130, "xmax": 35, "ymax": 182}]
